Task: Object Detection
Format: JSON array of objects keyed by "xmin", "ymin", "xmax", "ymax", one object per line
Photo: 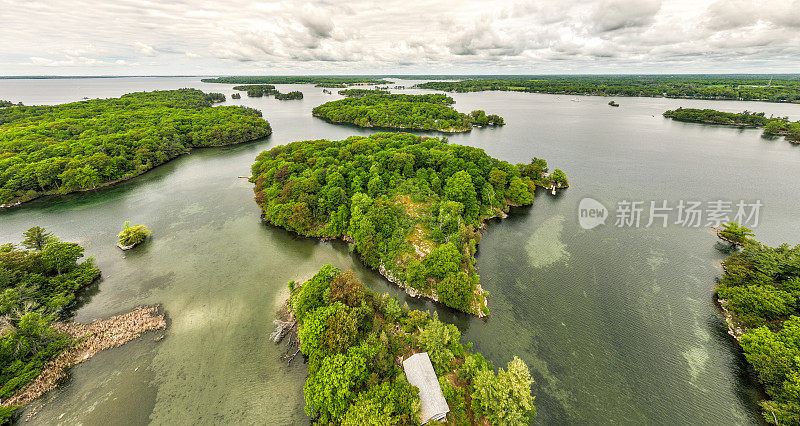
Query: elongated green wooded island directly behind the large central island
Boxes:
[{"xmin": 312, "ymin": 91, "xmax": 505, "ymax": 133}]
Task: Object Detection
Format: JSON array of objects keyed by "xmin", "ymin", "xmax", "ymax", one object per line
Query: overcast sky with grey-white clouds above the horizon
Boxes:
[{"xmin": 0, "ymin": 0, "xmax": 800, "ymax": 75}]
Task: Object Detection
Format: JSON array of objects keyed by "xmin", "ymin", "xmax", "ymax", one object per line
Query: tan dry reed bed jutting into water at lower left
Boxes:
[{"xmin": 0, "ymin": 305, "xmax": 167, "ymax": 407}]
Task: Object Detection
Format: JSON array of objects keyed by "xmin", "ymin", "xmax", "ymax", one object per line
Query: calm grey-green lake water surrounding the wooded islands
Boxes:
[{"xmin": 0, "ymin": 77, "xmax": 800, "ymax": 425}]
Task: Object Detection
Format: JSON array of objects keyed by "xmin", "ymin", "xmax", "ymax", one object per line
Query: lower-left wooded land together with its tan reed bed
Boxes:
[{"xmin": 0, "ymin": 227, "xmax": 166, "ymax": 423}]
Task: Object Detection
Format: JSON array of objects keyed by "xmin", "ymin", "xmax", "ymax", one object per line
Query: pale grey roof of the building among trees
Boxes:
[{"xmin": 403, "ymin": 352, "xmax": 450, "ymax": 424}]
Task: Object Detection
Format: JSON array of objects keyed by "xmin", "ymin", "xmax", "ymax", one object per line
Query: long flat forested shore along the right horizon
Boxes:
[{"xmin": 415, "ymin": 75, "xmax": 800, "ymax": 102}]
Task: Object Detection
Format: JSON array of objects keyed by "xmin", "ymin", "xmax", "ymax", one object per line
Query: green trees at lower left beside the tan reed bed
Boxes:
[{"xmin": 0, "ymin": 227, "xmax": 100, "ymax": 422}]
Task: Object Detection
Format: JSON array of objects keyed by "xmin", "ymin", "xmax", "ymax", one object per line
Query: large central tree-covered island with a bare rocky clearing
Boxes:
[{"xmin": 250, "ymin": 133, "xmax": 567, "ymax": 316}]
